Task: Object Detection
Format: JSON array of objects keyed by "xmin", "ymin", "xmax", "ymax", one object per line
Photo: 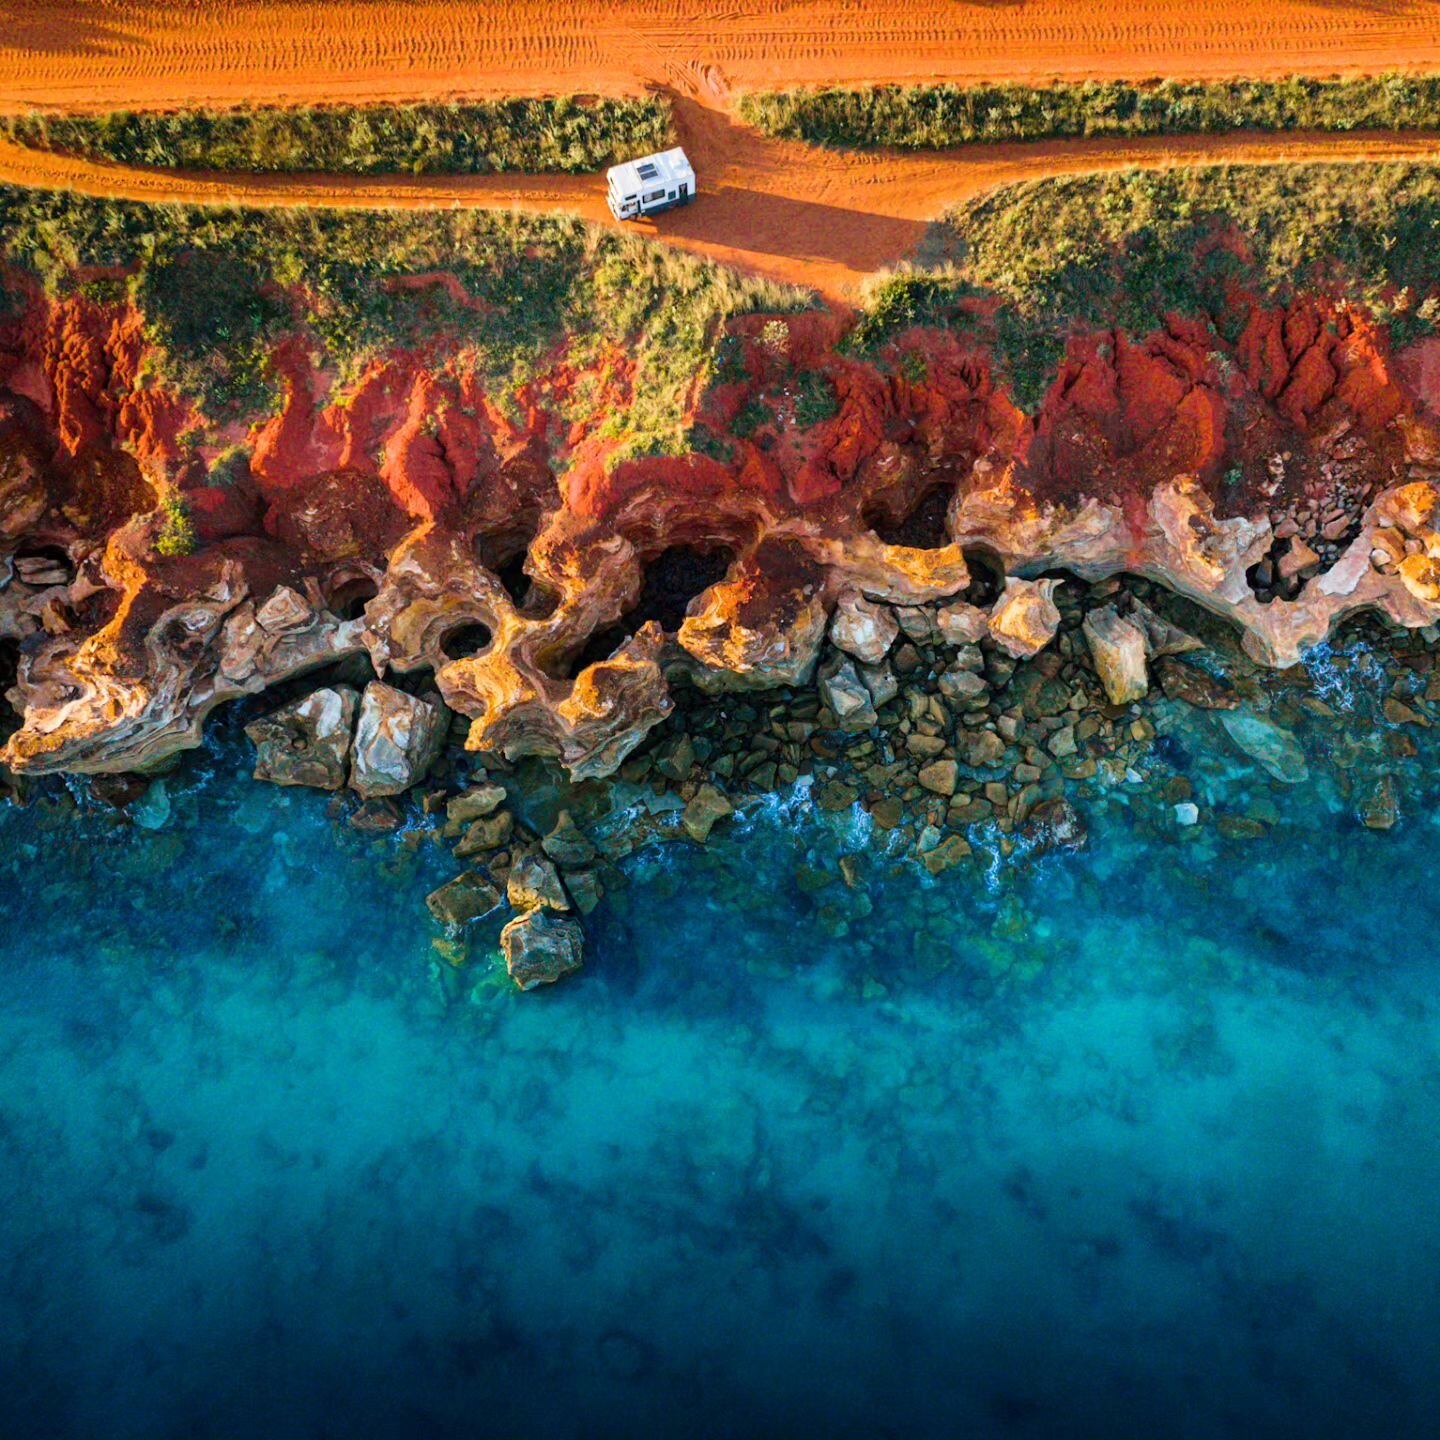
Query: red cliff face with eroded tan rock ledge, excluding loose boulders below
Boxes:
[{"xmin": 0, "ymin": 279, "xmax": 1440, "ymax": 783}]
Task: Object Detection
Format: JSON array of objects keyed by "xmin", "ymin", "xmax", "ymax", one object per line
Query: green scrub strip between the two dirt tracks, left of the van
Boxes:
[{"xmin": 0, "ymin": 95, "xmax": 672, "ymax": 174}]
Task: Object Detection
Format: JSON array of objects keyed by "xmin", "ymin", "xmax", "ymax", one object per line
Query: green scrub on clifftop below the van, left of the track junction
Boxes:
[{"xmin": 0, "ymin": 187, "xmax": 812, "ymax": 455}]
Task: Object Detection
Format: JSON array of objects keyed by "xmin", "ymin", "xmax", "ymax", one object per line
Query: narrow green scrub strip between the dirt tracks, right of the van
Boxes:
[{"xmin": 740, "ymin": 73, "xmax": 1440, "ymax": 150}]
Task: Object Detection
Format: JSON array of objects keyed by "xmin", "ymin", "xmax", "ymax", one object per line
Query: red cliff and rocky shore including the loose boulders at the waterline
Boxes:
[{"xmin": 8, "ymin": 272, "xmax": 1440, "ymax": 986}]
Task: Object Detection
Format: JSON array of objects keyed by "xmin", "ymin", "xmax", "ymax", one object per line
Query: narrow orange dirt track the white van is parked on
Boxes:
[{"xmin": 8, "ymin": 118, "xmax": 1440, "ymax": 304}]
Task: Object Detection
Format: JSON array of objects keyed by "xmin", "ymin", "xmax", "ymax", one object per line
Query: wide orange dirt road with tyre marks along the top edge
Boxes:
[{"xmin": 8, "ymin": 0, "xmax": 1440, "ymax": 108}]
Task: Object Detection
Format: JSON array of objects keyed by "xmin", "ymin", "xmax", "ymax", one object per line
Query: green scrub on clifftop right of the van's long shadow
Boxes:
[{"xmin": 850, "ymin": 164, "xmax": 1440, "ymax": 408}]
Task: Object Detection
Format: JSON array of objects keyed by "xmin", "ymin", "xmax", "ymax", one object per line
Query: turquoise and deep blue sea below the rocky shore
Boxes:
[{"xmin": 0, "ymin": 705, "xmax": 1440, "ymax": 1440}]
